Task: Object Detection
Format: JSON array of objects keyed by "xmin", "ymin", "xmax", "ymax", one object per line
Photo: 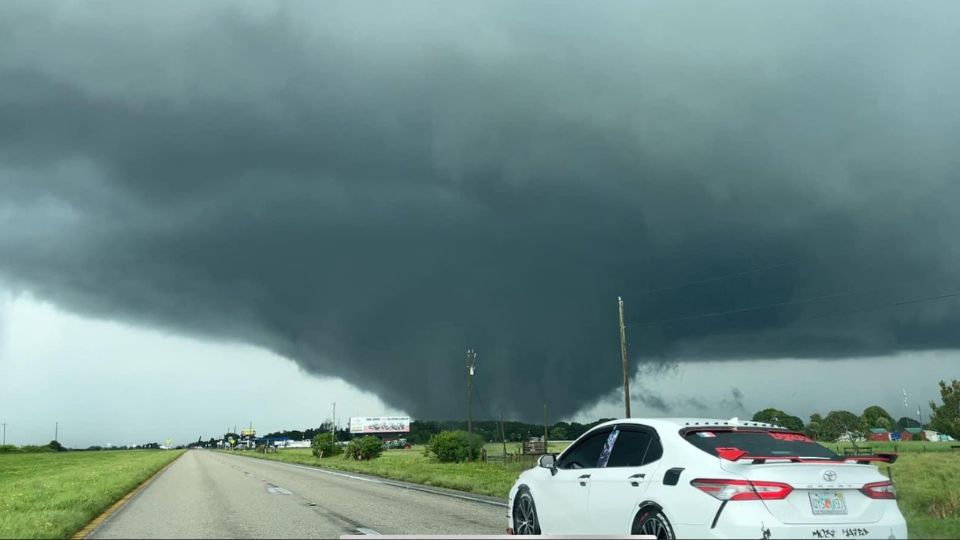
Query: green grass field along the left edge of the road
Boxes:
[{"xmin": 0, "ymin": 450, "xmax": 182, "ymax": 538}]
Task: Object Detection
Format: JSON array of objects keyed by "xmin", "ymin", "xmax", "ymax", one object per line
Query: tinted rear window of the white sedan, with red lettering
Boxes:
[{"xmin": 684, "ymin": 430, "xmax": 839, "ymax": 459}]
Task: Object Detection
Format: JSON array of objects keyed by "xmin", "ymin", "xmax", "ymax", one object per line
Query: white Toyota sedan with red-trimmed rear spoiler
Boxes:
[{"xmin": 507, "ymin": 418, "xmax": 907, "ymax": 539}]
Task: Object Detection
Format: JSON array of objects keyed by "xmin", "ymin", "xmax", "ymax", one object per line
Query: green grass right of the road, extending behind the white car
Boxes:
[{"xmin": 231, "ymin": 442, "xmax": 960, "ymax": 538}]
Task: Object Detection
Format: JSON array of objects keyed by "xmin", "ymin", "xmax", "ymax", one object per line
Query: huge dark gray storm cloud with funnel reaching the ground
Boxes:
[{"xmin": 0, "ymin": 2, "xmax": 960, "ymax": 417}]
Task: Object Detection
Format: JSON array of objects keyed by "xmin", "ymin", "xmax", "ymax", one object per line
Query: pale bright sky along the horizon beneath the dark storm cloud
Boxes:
[{"xmin": 0, "ymin": 293, "xmax": 957, "ymax": 448}]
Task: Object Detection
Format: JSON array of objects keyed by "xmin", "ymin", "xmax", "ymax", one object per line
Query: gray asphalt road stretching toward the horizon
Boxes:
[{"xmin": 93, "ymin": 450, "xmax": 506, "ymax": 538}]
